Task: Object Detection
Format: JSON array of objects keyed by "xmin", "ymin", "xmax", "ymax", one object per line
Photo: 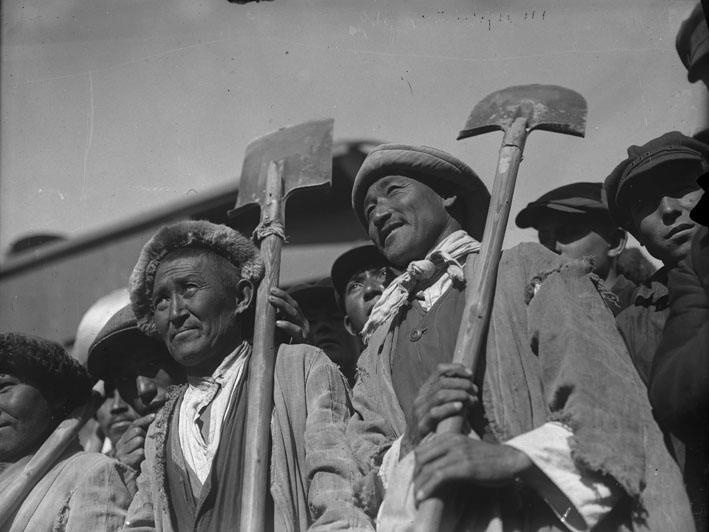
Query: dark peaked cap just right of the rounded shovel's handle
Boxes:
[{"xmin": 515, "ymin": 182, "xmax": 610, "ymax": 229}]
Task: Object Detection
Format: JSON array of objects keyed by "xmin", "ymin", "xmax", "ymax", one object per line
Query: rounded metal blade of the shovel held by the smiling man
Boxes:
[{"xmin": 458, "ymin": 84, "xmax": 587, "ymax": 140}]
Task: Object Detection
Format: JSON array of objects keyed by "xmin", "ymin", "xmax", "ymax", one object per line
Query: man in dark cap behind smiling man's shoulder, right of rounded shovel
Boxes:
[{"xmin": 515, "ymin": 182, "xmax": 654, "ymax": 315}]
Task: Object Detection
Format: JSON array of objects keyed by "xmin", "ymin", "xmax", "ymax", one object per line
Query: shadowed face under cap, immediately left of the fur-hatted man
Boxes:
[{"xmin": 108, "ymin": 340, "xmax": 185, "ymax": 416}]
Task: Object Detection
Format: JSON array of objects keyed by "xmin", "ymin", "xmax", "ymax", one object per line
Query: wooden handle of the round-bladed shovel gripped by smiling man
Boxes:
[{"xmin": 415, "ymin": 118, "xmax": 527, "ymax": 532}]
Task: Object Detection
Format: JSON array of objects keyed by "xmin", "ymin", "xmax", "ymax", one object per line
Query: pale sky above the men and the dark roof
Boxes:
[{"xmin": 0, "ymin": 0, "xmax": 706, "ymax": 258}]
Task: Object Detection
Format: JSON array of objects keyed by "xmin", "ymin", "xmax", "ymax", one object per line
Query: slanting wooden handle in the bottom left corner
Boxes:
[{"xmin": 0, "ymin": 397, "xmax": 100, "ymax": 529}]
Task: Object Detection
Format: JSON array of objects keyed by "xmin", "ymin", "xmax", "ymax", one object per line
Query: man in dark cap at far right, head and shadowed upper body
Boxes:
[{"xmin": 604, "ymin": 131, "xmax": 709, "ymax": 384}]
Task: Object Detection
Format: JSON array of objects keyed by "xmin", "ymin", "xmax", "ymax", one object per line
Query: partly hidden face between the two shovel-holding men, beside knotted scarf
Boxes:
[{"xmin": 343, "ymin": 266, "xmax": 396, "ymax": 333}]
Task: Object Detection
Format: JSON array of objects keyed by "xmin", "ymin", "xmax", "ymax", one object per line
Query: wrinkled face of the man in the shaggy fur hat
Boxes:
[{"xmin": 153, "ymin": 250, "xmax": 252, "ymax": 368}]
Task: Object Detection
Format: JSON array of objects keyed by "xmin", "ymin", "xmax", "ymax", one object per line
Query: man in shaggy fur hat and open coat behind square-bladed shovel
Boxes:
[{"xmin": 121, "ymin": 221, "xmax": 351, "ymax": 531}]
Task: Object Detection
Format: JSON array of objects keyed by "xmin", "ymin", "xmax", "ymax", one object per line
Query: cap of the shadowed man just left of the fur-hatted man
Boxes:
[{"xmin": 86, "ymin": 304, "xmax": 170, "ymax": 380}]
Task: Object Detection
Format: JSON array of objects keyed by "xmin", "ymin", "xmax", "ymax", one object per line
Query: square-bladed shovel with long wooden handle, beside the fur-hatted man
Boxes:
[{"xmin": 229, "ymin": 119, "xmax": 333, "ymax": 531}]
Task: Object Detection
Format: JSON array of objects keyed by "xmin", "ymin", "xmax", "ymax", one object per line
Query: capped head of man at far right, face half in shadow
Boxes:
[{"xmin": 604, "ymin": 131, "xmax": 709, "ymax": 267}]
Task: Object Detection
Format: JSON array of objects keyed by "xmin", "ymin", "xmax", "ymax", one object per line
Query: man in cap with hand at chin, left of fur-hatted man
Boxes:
[{"xmin": 87, "ymin": 304, "xmax": 185, "ymax": 470}]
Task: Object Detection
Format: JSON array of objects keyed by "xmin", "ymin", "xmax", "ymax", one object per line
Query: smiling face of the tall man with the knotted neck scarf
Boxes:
[{"xmin": 364, "ymin": 175, "xmax": 460, "ymax": 266}]
